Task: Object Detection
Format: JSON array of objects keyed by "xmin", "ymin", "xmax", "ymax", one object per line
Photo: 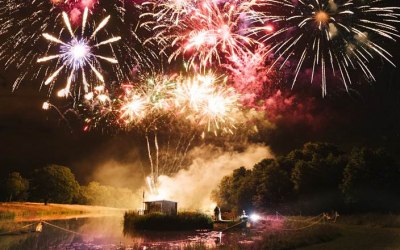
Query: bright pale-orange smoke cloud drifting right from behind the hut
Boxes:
[{"xmin": 143, "ymin": 144, "xmax": 272, "ymax": 211}]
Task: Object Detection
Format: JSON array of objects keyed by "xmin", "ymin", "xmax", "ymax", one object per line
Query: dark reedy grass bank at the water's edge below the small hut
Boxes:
[{"xmin": 124, "ymin": 212, "xmax": 213, "ymax": 231}]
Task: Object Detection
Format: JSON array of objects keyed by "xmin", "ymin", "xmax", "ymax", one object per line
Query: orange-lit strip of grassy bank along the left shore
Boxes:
[{"xmin": 0, "ymin": 202, "xmax": 127, "ymax": 221}]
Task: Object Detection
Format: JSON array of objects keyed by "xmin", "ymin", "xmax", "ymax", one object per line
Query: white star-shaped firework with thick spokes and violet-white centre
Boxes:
[{"xmin": 37, "ymin": 8, "xmax": 121, "ymax": 97}]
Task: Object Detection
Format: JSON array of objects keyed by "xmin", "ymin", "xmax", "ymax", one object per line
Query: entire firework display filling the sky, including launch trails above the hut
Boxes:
[{"xmin": 0, "ymin": 0, "xmax": 400, "ymax": 194}]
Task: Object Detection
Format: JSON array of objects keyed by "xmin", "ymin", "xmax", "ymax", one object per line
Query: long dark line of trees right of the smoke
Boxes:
[{"xmin": 212, "ymin": 143, "xmax": 400, "ymax": 214}]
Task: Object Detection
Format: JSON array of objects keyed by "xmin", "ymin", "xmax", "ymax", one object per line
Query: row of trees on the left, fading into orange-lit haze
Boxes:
[{"xmin": 0, "ymin": 165, "xmax": 134, "ymax": 208}]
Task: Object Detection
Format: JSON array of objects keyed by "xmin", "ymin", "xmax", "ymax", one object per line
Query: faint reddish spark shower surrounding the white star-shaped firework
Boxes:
[{"xmin": 0, "ymin": 0, "xmax": 157, "ymax": 93}]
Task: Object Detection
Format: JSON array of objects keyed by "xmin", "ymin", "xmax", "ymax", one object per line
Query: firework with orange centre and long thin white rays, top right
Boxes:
[{"xmin": 253, "ymin": 0, "xmax": 400, "ymax": 96}]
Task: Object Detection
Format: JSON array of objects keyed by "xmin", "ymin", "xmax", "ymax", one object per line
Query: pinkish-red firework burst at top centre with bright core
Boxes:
[{"xmin": 143, "ymin": 1, "xmax": 261, "ymax": 68}]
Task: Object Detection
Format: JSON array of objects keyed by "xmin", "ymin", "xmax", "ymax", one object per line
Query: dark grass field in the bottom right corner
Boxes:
[{"xmin": 252, "ymin": 214, "xmax": 400, "ymax": 250}]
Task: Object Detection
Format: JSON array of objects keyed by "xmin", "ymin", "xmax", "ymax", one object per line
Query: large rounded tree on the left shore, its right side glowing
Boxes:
[{"xmin": 32, "ymin": 165, "xmax": 79, "ymax": 204}]
